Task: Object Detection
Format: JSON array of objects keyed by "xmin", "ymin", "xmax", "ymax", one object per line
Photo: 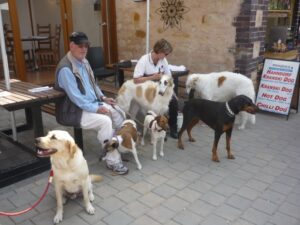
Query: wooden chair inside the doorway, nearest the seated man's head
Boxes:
[{"xmin": 36, "ymin": 24, "xmax": 61, "ymax": 69}]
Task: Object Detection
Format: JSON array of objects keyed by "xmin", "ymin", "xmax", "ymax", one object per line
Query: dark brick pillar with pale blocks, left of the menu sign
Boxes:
[{"xmin": 234, "ymin": 0, "xmax": 268, "ymax": 81}]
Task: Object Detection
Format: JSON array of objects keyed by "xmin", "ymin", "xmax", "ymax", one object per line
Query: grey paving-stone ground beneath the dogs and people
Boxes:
[{"xmin": 0, "ymin": 108, "xmax": 300, "ymax": 225}]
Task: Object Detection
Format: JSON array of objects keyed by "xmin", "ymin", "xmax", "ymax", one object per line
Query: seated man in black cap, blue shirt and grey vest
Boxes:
[{"xmin": 55, "ymin": 32, "xmax": 128, "ymax": 174}]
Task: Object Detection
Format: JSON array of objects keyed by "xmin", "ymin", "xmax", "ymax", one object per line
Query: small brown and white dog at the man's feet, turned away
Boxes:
[{"xmin": 104, "ymin": 120, "xmax": 142, "ymax": 170}]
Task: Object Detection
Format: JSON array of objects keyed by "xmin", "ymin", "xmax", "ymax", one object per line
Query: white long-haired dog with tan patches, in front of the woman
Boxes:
[{"xmin": 117, "ymin": 75, "xmax": 174, "ymax": 115}]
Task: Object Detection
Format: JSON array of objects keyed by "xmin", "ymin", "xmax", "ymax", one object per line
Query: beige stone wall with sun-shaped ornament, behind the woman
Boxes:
[{"xmin": 116, "ymin": 0, "xmax": 242, "ymax": 73}]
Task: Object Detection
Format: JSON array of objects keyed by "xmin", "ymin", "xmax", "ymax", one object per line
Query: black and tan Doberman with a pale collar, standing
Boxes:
[{"xmin": 177, "ymin": 95, "xmax": 257, "ymax": 162}]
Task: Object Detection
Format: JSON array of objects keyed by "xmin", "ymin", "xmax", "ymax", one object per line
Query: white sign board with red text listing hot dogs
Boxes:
[{"xmin": 256, "ymin": 59, "xmax": 299, "ymax": 115}]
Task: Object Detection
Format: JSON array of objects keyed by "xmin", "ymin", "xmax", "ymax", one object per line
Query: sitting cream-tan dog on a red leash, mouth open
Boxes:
[{"xmin": 35, "ymin": 130, "xmax": 102, "ymax": 223}]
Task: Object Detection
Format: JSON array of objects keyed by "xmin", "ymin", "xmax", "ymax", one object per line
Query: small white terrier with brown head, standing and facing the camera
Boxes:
[{"xmin": 141, "ymin": 111, "xmax": 169, "ymax": 160}]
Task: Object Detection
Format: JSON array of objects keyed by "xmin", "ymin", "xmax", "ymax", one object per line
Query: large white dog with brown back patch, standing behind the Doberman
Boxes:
[{"xmin": 186, "ymin": 72, "xmax": 255, "ymax": 129}]
